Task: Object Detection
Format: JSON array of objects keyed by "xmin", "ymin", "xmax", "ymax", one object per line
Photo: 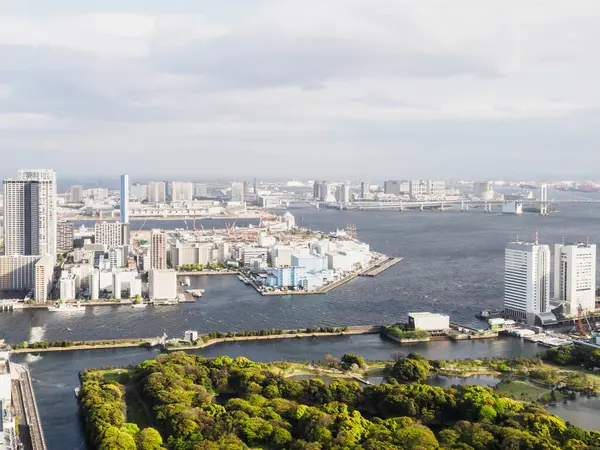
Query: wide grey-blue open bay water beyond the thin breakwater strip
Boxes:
[{"xmin": 5, "ymin": 204, "xmax": 600, "ymax": 342}]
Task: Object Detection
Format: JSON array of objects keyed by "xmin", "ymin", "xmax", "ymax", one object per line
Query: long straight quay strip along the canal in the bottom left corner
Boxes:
[{"xmin": 10, "ymin": 363, "xmax": 47, "ymax": 450}]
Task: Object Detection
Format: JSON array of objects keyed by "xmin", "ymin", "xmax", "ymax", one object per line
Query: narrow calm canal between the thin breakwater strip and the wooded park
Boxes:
[{"xmin": 13, "ymin": 335, "xmax": 538, "ymax": 450}]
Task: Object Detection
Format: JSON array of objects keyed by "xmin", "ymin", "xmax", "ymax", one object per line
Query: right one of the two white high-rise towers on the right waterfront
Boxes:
[{"xmin": 554, "ymin": 244, "xmax": 596, "ymax": 314}]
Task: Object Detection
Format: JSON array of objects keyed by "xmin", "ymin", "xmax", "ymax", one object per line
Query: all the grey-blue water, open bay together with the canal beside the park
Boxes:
[{"xmin": 0, "ymin": 201, "xmax": 600, "ymax": 450}]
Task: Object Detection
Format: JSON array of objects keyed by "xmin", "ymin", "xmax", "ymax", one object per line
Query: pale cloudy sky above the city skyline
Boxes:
[{"xmin": 0, "ymin": 0, "xmax": 600, "ymax": 179}]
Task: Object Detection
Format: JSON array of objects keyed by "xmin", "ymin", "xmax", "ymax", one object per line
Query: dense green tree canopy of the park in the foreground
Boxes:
[{"xmin": 80, "ymin": 352, "xmax": 600, "ymax": 450}]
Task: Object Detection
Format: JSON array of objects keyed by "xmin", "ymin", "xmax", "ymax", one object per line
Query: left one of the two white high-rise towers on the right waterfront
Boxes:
[{"xmin": 504, "ymin": 242, "xmax": 550, "ymax": 323}]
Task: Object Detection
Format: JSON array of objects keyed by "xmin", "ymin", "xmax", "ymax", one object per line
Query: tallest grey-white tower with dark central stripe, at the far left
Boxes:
[{"xmin": 4, "ymin": 170, "xmax": 57, "ymax": 258}]
